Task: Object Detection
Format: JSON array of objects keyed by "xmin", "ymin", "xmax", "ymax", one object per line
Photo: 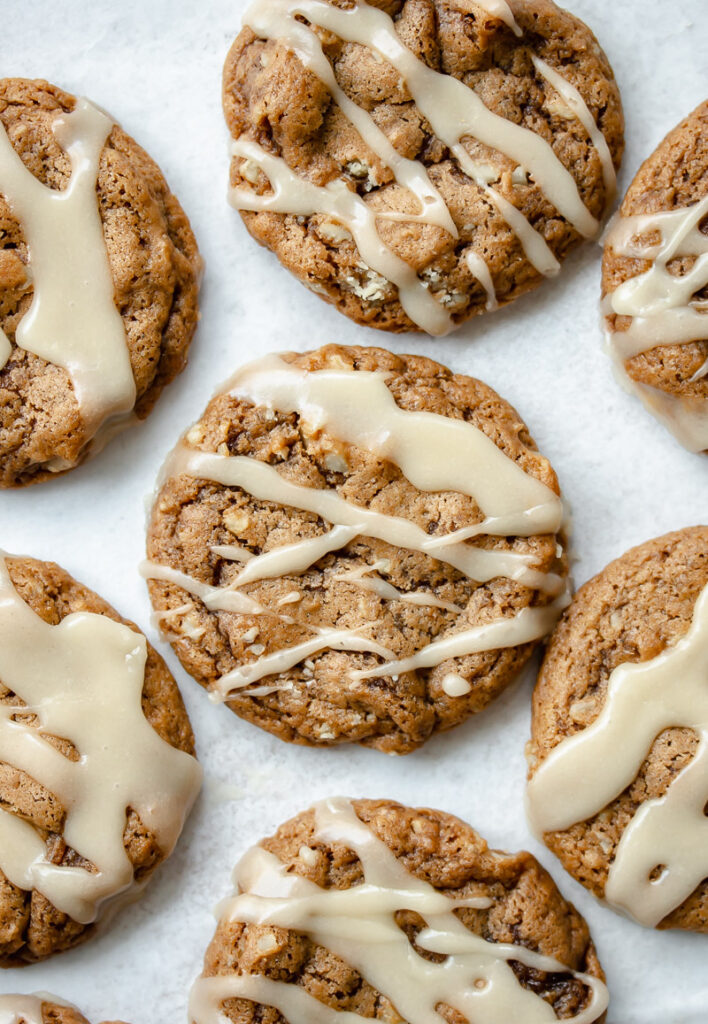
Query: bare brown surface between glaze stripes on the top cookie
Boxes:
[{"xmin": 223, "ymin": 0, "xmax": 623, "ymax": 331}]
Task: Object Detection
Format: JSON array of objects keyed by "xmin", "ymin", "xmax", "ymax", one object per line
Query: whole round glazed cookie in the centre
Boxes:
[{"xmin": 143, "ymin": 345, "xmax": 566, "ymax": 754}]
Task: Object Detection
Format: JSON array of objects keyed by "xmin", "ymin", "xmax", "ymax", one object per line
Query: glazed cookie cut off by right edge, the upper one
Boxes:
[{"xmin": 602, "ymin": 100, "xmax": 708, "ymax": 452}]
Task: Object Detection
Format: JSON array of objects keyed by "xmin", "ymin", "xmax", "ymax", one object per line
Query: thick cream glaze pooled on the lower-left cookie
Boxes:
[{"xmin": 0, "ymin": 556, "xmax": 201, "ymax": 924}]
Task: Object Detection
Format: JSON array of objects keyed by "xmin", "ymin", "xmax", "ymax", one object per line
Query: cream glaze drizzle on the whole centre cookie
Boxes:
[{"xmin": 146, "ymin": 354, "xmax": 567, "ymax": 699}]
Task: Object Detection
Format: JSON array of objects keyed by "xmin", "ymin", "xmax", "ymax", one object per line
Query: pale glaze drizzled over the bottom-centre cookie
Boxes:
[{"xmin": 190, "ymin": 798, "xmax": 608, "ymax": 1024}]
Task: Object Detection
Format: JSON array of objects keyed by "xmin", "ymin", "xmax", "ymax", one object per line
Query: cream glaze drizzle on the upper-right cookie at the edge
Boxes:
[{"xmin": 602, "ymin": 196, "xmax": 708, "ymax": 452}]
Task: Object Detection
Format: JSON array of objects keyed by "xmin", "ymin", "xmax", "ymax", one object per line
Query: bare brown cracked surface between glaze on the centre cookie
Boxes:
[{"xmin": 145, "ymin": 345, "xmax": 567, "ymax": 754}]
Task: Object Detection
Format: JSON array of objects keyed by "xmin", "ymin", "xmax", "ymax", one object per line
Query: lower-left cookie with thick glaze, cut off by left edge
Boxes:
[{"xmin": 0, "ymin": 556, "xmax": 201, "ymax": 967}]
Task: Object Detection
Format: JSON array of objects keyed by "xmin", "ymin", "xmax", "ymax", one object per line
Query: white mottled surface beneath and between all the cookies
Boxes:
[{"xmin": 0, "ymin": 0, "xmax": 708, "ymax": 1024}]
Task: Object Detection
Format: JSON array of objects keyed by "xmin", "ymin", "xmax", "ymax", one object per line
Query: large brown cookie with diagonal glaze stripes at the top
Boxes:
[{"xmin": 223, "ymin": 0, "xmax": 624, "ymax": 335}]
